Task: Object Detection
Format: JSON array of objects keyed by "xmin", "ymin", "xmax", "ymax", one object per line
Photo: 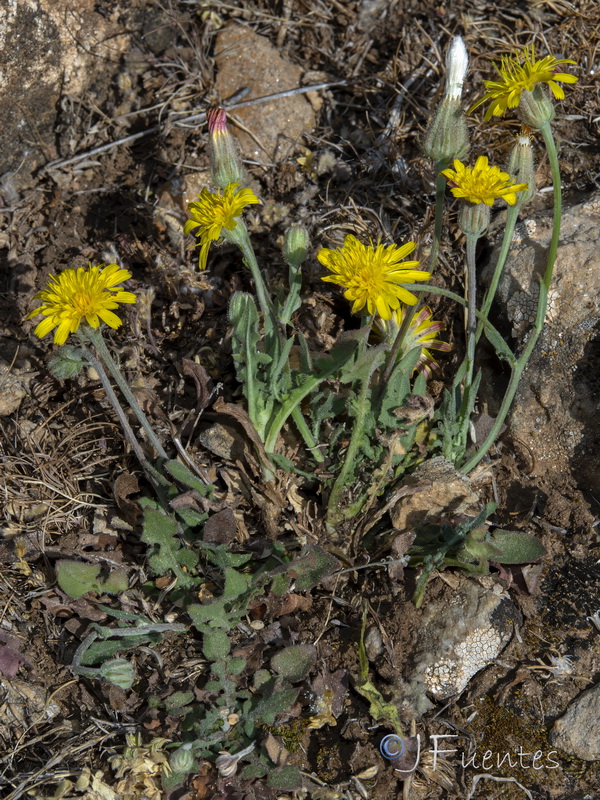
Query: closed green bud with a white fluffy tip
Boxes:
[{"xmin": 423, "ymin": 36, "xmax": 469, "ymax": 162}]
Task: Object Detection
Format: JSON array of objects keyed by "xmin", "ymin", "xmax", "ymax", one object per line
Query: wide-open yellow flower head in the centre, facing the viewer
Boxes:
[{"xmin": 317, "ymin": 235, "xmax": 431, "ymax": 320}]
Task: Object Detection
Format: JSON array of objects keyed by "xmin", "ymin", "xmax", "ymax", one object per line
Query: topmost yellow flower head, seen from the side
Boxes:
[{"xmin": 469, "ymin": 45, "xmax": 577, "ymax": 120}]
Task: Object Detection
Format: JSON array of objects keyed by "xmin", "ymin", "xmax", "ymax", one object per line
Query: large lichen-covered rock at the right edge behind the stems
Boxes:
[{"xmin": 483, "ymin": 193, "xmax": 600, "ymax": 494}]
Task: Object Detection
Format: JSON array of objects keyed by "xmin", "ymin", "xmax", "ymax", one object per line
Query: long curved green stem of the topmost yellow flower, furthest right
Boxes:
[{"xmin": 461, "ymin": 123, "xmax": 562, "ymax": 473}]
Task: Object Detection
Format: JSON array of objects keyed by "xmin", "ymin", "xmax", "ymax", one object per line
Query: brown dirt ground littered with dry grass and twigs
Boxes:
[{"xmin": 0, "ymin": 0, "xmax": 600, "ymax": 800}]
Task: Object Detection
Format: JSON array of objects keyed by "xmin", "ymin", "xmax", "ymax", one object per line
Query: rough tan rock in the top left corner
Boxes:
[{"xmin": 0, "ymin": 0, "xmax": 129, "ymax": 174}]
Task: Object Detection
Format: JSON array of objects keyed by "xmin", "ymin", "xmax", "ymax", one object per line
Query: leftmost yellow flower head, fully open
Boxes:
[{"xmin": 26, "ymin": 264, "xmax": 136, "ymax": 344}]
